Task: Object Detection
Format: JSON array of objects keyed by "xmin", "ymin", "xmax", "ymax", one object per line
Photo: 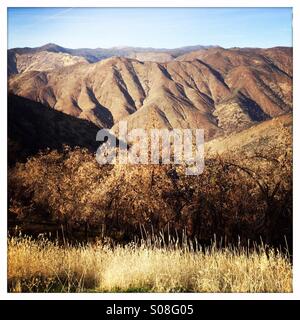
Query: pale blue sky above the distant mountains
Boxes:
[{"xmin": 8, "ymin": 8, "xmax": 292, "ymax": 48}]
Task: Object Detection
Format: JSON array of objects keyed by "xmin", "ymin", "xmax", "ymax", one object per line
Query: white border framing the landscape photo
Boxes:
[{"xmin": 0, "ymin": 0, "xmax": 300, "ymax": 300}]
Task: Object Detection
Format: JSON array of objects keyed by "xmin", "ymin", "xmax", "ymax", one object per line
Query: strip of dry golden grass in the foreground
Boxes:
[{"xmin": 8, "ymin": 237, "xmax": 292, "ymax": 292}]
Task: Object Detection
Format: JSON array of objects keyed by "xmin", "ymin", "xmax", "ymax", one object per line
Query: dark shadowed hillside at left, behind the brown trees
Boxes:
[{"xmin": 8, "ymin": 95, "xmax": 99, "ymax": 164}]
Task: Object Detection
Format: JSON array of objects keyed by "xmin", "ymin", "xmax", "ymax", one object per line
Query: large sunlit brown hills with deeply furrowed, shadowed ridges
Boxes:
[{"xmin": 9, "ymin": 48, "xmax": 292, "ymax": 137}]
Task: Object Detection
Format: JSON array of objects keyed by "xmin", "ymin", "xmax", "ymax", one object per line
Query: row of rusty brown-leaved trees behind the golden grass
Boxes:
[{"xmin": 8, "ymin": 128, "xmax": 292, "ymax": 250}]
